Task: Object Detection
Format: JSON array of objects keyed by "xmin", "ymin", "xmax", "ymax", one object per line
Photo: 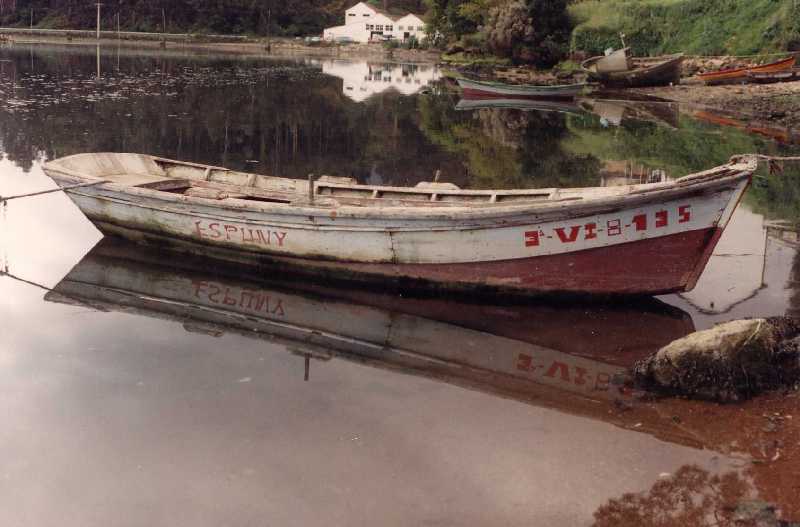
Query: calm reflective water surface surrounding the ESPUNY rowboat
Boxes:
[{"xmin": 0, "ymin": 46, "xmax": 800, "ymax": 526}]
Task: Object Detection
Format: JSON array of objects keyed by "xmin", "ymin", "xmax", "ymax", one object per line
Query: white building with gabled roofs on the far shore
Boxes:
[{"xmin": 323, "ymin": 2, "xmax": 425, "ymax": 43}]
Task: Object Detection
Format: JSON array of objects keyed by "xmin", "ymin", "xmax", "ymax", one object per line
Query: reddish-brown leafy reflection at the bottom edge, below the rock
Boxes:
[{"xmin": 594, "ymin": 465, "xmax": 756, "ymax": 527}]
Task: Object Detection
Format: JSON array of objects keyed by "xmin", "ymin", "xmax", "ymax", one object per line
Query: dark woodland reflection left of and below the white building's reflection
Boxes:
[{"xmin": 0, "ymin": 46, "xmax": 457, "ymax": 184}]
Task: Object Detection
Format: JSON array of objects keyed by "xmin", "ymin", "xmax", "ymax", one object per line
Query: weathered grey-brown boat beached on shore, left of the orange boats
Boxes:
[{"xmin": 581, "ymin": 49, "xmax": 683, "ymax": 88}]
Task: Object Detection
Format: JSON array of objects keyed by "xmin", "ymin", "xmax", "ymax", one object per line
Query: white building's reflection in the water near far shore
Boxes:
[{"xmin": 322, "ymin": 60, "xmax": 441, "ymax": 102}]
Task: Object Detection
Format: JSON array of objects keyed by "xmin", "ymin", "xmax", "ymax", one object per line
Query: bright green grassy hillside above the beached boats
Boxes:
[{"xmin": 569, "ymin": 0, "xmax": 800, "ymax": 55}]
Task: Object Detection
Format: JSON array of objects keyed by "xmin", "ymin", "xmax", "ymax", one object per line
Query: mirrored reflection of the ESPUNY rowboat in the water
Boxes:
[{"xmin": 46, "ymin": 239, "xmax": 694, "ymax": 444}]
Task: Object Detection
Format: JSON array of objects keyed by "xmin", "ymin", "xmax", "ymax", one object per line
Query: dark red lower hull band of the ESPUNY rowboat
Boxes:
[{"xmin": 97, "ymin": 223, "xmax": 722, "ymax": 295}]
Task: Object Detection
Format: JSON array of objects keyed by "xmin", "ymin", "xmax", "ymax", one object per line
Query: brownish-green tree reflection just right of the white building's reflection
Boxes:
[{"xmin": 420, "ymin": 96, "xmax": 600, "ymax": 188}]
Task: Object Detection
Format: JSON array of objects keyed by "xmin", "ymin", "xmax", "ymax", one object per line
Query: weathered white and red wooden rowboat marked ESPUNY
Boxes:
[{"xmin": 44, "ymin": 153, "xmax": 757, "ymax": 295}]
